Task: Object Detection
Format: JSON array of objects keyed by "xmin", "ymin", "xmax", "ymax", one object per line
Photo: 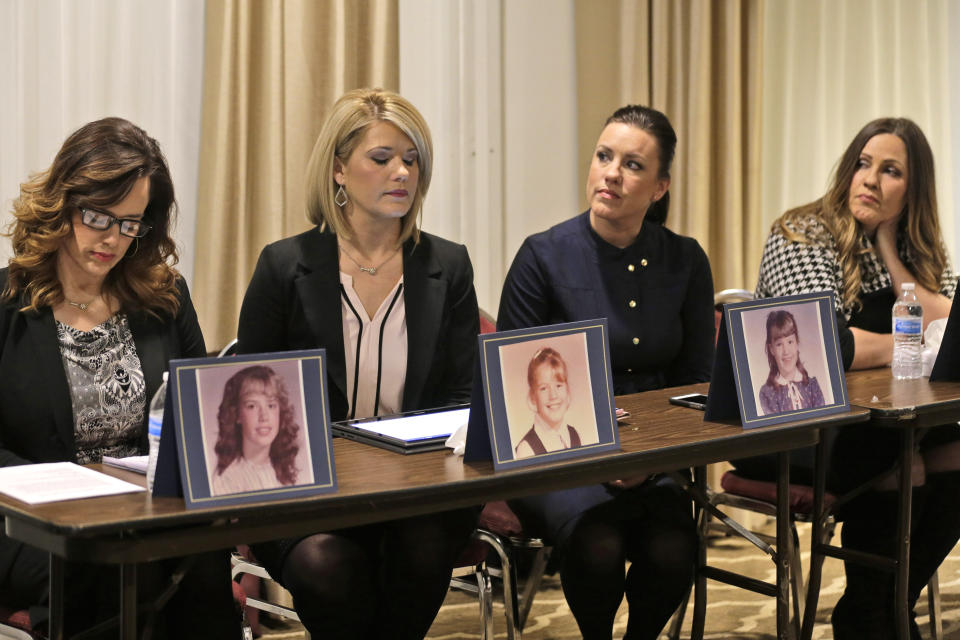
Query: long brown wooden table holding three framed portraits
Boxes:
[{"xmin": 0, "ymin": 384, "xmax": 866, "ymax": 640}]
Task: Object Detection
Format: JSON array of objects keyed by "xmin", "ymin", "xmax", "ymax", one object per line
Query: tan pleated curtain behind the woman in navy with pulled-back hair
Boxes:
[{"xmin": 577, "ymin": 0, "xmax": 766, "ymax": 289}]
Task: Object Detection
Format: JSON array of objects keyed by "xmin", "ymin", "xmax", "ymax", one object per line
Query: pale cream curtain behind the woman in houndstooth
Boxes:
[{"xmin": 763, "ymin": 0, "xmax": 960, "ymax": 265}]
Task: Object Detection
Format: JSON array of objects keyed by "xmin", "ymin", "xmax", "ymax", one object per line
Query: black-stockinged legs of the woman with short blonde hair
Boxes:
[{"xmin": 282, "ymin": 509, "xmax": 477, "ymax": 640}]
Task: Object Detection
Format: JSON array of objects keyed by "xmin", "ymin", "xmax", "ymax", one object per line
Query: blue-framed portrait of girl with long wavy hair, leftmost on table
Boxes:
[{"xmin": 165, "ymin": 349, "xmax": 337, "ymax": 508}]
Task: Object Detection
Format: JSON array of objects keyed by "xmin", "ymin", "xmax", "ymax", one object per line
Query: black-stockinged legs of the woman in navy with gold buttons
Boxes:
[{"xmin": 560, "ymin": 488, "xmax": 697, "ymax": 640}]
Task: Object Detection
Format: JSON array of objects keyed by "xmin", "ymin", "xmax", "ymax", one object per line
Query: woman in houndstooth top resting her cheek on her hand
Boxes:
[{"xmin": 734, "ymin": 118, "xmax": 960, "ymax": 640}]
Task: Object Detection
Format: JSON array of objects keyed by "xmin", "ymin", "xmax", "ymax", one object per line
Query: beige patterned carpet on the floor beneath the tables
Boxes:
[{"xmin": 255, "ymin": 525, "xmax": 960, "ymax": 640}]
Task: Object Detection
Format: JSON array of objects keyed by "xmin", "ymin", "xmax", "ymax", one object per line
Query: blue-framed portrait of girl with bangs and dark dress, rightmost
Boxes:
[{"xmin": 724, "ymin": 292, "xmax": 850, "ymax": 427}]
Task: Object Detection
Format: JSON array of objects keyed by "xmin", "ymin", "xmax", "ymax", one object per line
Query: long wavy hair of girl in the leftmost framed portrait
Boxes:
[{"xmin": 214, "ymin": 365, "xmax": 300, "ymax": 484}]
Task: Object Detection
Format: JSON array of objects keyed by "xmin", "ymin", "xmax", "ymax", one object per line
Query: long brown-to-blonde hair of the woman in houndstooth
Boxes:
[{"xmin": 774, "ymin": 118, "xmax": 947, "ymax": 316}]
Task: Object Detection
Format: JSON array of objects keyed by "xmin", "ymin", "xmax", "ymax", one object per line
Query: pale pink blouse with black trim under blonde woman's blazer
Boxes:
[{"xmin": 340, "ymin": 272, "xmax": 407, "ymax": 418}]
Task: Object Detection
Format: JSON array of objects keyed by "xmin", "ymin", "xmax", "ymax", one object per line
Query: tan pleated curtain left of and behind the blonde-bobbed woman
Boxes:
[{"xmin": 194, "ymin": 0, "xmax": 399, "ymax": 349}]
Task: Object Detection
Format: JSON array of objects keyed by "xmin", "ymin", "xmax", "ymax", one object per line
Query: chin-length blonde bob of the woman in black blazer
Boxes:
[{"xmin": 306, "ymin": 89, "xmax": 433, "ymax": 244}]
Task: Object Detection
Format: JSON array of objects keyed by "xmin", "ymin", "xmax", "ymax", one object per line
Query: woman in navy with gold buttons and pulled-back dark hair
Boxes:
[{"xmin": 497, "ymin": 105, "xmax": 714, "ymax": 640}]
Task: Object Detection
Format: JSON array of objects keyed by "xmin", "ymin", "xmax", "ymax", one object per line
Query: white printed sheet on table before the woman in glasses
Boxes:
[{"xmin": 0, "ymin": 462, "xmax": 144, "ymax": 504}]
